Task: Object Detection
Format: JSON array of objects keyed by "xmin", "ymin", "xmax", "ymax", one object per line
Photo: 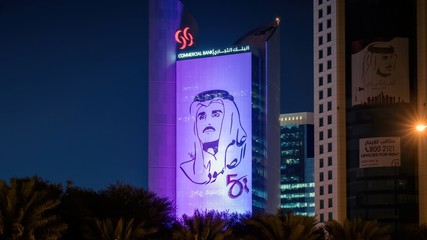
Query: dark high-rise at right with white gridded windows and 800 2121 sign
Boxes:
[{"xmin": 313, "ymin": 0, "xmax": 427, "ymax": 226}]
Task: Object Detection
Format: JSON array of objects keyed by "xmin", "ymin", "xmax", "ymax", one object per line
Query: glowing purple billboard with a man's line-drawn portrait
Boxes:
[{"xmin": 176, "ymin": 52, "xmax": 252, "ymax": 216}]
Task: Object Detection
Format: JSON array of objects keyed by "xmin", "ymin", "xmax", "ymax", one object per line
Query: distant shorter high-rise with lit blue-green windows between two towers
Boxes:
[{"xmin": 280, "ymin": 112, "xmax": 316, "ymax": 216}]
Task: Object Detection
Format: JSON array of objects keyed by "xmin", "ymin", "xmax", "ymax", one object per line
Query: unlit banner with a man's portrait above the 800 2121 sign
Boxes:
[{"xmin": 351, "ymin": 38, "xmax": 409, "ymax": 106}]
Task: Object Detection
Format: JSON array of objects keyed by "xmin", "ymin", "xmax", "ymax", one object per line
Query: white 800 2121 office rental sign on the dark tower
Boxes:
[{"xmin": 359, "ymin": 137, "xmax": 400, "ymax": 168}]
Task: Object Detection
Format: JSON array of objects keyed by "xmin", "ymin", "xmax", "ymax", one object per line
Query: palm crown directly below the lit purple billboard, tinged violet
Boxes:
[{"xmin": 173, "ymin": 210, "xmax": 231, "ymax": 240}]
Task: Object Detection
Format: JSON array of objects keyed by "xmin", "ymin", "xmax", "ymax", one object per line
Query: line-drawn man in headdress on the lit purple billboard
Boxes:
[{"xmin": 180, "ymin": 90, "xmax": 247, "ymax": 184}]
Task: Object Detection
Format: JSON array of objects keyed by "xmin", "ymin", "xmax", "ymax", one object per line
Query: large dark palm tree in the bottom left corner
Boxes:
[{"xmin": 0, "ymin": 176, "xmax": 67, "ymax": 240}]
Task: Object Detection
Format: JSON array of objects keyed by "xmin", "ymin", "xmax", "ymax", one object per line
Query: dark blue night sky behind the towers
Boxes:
[{"xmin": 0, "ymin": 0, "xmax": 313, "ymax": 190}]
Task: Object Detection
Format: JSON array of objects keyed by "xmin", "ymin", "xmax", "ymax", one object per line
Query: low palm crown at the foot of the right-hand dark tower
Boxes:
[{"xmin": 324, "ymin": 219, "xmax": 391, "ymax": 240}]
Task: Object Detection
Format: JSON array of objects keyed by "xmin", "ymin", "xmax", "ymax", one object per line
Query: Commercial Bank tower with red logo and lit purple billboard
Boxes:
[{"xmin": 148, "ymin": 0, "xmax": 280, "ymax": 216}]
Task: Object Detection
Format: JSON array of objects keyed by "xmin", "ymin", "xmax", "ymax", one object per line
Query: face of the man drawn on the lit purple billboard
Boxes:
[{"xmin": 196, "ymin": 102, "xmax": 224, "ymax": 143}]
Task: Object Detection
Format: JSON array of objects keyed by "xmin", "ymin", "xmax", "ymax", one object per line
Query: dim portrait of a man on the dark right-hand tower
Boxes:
[{"xmin": 353, "ymin": 39, "xmax": 408, "ymax": 104}]
